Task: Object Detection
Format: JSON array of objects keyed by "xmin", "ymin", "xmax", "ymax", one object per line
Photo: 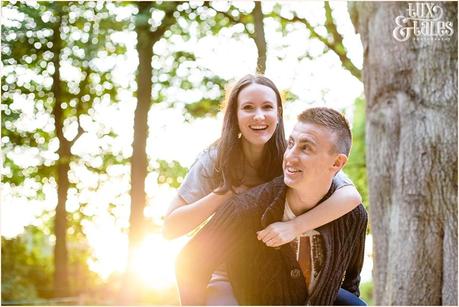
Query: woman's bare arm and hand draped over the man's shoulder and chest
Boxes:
[{"xmin": 257, "ymin": 185, "xmax": 362, "ymax": 247}]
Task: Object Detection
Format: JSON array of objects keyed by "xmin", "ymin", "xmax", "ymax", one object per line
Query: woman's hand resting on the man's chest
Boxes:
[{"xmin": 257, "ymin": 221, "xmax": 298, "ymax": 247}]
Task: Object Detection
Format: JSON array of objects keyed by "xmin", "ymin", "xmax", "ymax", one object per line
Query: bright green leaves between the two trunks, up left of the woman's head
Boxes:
[{"xmin": 149, "ymin": 2, "xmax": 254, "ymax": 122}]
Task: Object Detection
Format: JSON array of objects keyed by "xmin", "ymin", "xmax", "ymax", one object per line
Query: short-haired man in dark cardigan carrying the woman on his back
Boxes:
[{"xmin": 177, "ymin": 108, "xmax": 367, "ymax": 305}]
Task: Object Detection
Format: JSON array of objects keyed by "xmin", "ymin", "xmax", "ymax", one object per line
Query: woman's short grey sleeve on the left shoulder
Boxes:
[{"xmin": 177, "ymin": 150, "xmax": 216, "ymax": 204}]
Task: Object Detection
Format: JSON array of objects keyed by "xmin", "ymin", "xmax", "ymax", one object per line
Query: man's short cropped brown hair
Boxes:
[{"xmin": 298, "ymin": 107, "xmax": 352, "ymax": 156}]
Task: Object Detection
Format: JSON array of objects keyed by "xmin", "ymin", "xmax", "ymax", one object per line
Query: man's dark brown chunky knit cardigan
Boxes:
[{"xmin": 176, "ymin": 177, "xmax": 368, "ymax": 305}]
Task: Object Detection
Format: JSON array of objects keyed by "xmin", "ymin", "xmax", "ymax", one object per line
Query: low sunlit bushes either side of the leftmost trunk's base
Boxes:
[{"xmin": 2, "ymin": 221, "xmax": 101, "ymax": 305}]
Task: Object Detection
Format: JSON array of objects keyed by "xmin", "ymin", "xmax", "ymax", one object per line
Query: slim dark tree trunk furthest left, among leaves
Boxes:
[{"xmin": 52, "ymin": 3, "xmax": 71, "ymax": 297}]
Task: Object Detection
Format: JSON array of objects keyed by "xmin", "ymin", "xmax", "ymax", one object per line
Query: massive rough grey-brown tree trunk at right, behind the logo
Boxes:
[{"xmin": 350, "ymin": 2, "xmax": 458, "ymax": 305}]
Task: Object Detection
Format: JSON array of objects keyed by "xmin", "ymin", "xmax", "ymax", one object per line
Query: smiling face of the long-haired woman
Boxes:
[{"xmin": 237, "ymin": 83, "xmax": 279, "ymax": 145}]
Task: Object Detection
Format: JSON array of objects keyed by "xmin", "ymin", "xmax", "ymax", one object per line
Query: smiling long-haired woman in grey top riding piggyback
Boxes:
[{"xmin": 163, "ymin": 75, "xmax": 361, "ymax": 305}]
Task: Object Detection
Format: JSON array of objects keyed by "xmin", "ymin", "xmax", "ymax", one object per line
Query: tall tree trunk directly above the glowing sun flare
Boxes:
[{"xmin": 119, "ymin": 1, "xmax": 153, "ymax": 305}]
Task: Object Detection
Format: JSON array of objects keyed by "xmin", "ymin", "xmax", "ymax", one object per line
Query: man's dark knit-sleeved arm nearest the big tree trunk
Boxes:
[{"xmin": 341, "ymin": 205, "xmax": 368, "ymax": 296}]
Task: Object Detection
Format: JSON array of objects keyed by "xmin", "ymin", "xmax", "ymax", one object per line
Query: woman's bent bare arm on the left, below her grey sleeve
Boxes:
[{"xmin": 163, "ymin": 190, "xmax": 233, "ymax": 240}]
